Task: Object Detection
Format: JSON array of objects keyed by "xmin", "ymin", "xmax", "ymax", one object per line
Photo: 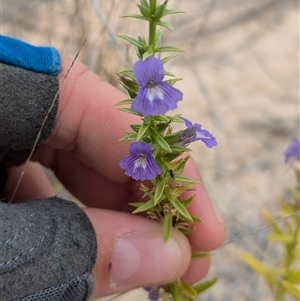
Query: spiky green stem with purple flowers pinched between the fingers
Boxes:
[{"xmin": 117, "ymin": 0, "xmax": 217, "ymax": 301}]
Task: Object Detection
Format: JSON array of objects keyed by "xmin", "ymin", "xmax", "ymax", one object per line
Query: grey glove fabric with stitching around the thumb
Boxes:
[{"xmin": 0, "ymin": 197, "xmax": 97, "ymax": 301}]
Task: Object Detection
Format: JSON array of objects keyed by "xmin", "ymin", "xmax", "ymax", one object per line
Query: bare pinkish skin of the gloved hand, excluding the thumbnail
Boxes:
[{"xmin": 4, "ymin": 58, "xmax": 225, "ymax": 298}]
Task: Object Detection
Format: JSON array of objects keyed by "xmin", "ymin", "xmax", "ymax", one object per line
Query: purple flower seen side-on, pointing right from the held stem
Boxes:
[{"xmin": 178, "ymin": 117, "xmax": 217, "ymax": 148}]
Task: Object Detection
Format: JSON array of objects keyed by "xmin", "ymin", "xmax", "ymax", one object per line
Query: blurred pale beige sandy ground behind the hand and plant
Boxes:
[{"xmin": 1, "ymin": 0, "xmax": 299, "ymax": 301}]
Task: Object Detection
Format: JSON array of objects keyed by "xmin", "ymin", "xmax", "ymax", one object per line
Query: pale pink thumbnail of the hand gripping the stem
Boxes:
[{"xmin": 111, "ymin": 231, "xmax": 181, "ymax": 286}]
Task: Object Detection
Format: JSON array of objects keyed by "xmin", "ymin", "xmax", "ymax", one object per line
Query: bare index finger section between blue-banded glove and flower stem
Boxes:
[{"xmin": 46, "ymin": 58, "xmax": 140, "ymax": 182}]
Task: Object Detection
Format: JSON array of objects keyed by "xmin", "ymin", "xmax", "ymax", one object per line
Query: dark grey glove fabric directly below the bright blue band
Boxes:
[{"xmin": 0, "ymin": 62, "xmax": 59, "ymax": 166}]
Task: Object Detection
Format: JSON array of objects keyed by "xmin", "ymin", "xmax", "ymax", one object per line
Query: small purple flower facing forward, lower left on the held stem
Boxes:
[{"xmin": 120, "ymin": 142, "xmax": 161, "ymax": 181}]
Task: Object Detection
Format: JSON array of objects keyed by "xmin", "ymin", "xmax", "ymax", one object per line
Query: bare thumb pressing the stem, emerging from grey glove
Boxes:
[{"xmin": 85, "ymin": 208, "xmax": 191, "ymax": 298}]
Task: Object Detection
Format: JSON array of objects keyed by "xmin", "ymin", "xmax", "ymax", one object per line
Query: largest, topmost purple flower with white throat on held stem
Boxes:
[{"xmin": 132, "ymin": 56, "xmax": 183, "ymax": 117}]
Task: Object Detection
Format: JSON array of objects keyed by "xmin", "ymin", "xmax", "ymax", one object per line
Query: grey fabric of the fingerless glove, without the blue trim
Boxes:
[{"xmin": 0, "ymin": 62, "xmax": 97, "ymax": 301}]
